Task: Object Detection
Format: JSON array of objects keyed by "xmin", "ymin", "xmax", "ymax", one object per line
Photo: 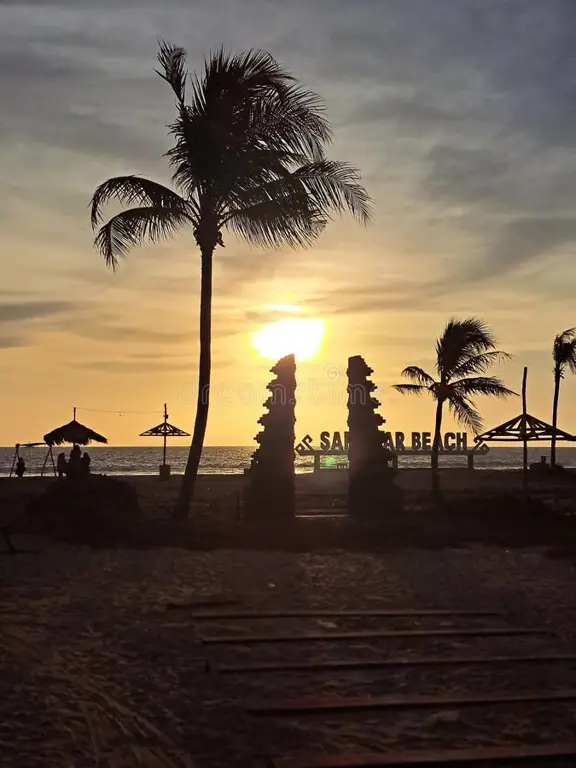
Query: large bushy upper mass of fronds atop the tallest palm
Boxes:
[{"xmin": 168, "ymin": 44, "xmax": 331, "ymax": 202}]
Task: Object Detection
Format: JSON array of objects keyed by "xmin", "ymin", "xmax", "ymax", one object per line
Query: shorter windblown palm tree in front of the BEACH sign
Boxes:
[{"xmin": 394, "ymin": 317, "xmax": 515, "ymax": 490}]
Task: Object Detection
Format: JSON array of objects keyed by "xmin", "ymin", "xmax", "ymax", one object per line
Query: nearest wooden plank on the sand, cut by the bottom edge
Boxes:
[{"xmin": 271, "ymin": 741, "xmax": 576, "ymax": 768}]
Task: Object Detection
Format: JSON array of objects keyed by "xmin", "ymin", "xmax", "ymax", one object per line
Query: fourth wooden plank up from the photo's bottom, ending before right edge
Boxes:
[{"xmin": 200, "ymin": 627, "xmax": 553, "ymax": 645}]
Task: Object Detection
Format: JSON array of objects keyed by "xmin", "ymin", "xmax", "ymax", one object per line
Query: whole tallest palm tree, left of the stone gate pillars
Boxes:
[{"xmin": 92, "ymin": 42, "xmax": 371, "ymax": 517}]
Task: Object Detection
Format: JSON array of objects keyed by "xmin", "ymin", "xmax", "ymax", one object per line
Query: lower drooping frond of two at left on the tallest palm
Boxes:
[{"xmin": 94, "ymin": 206, "xmax": 190, "ymax": 270}]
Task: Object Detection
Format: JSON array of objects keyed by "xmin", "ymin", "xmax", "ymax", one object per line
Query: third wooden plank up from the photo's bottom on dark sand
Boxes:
[{"xmin": 212, "ymin": 654, "xmax": 576, "ymax": 673}]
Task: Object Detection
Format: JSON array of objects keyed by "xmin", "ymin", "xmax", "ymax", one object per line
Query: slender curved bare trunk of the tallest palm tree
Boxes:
[{"xmin": 174, "ymin": 248, "xmax": 214, "ymax": 520}]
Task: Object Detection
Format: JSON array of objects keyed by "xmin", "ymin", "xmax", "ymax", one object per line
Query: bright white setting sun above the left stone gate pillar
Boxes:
[{"xmin": 252, "ymin": 318, "xmax": 324, "ymax": 361}]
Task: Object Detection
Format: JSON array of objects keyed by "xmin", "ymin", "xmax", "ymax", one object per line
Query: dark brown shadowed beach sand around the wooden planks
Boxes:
[{"xmin": 0, "ymin": 470, "xmax": 576, "ymax": 768}]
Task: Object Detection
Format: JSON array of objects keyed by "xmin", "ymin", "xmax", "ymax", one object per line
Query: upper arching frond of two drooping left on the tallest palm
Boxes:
[{"xmin": 90, "ymin": 176, "xmax": 191, "ymax": 229}]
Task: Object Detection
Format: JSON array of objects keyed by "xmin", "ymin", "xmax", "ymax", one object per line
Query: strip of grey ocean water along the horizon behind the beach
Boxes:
[{"xmin": 0, "ymin": 446, "xmax": 576, "ymax": 476}]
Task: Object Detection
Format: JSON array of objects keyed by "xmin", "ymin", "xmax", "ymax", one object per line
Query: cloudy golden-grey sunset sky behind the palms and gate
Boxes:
[{"xmin": 0, "ymin": 0, "xmax": 576, "ymax": 445}]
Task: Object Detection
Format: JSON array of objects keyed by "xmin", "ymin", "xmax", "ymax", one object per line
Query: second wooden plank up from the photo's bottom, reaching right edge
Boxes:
[{"xmin": 245, "ymin": 690, "xmax": 576, "ymax": 715}]
